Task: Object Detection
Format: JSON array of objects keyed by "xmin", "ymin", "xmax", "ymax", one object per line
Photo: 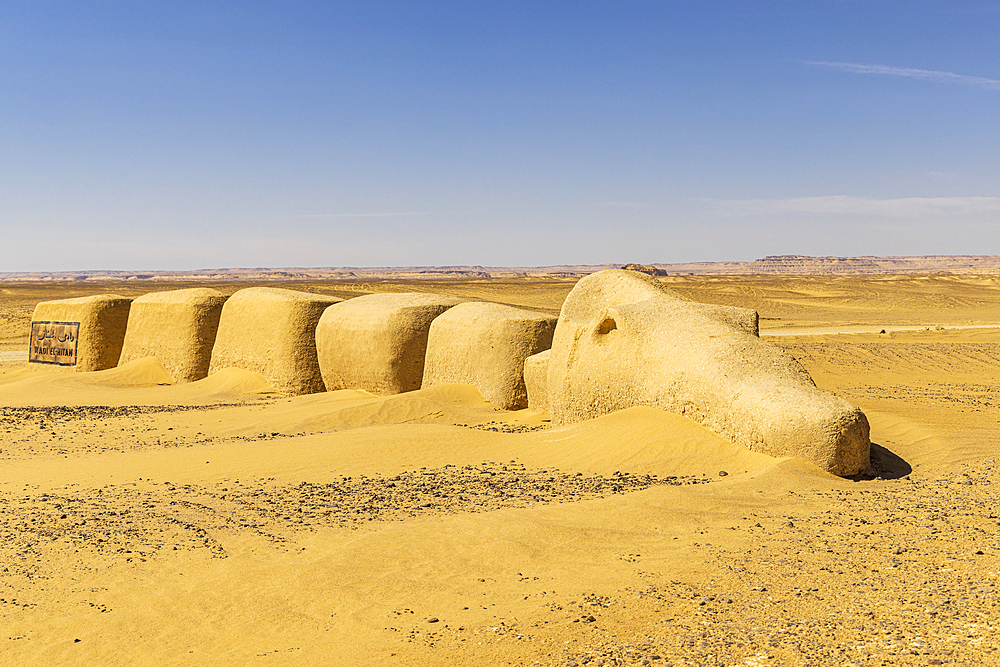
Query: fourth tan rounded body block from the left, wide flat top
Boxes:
[{"xmin": 316, "ymin": 292, "xmax": 462, "ymax": 395}]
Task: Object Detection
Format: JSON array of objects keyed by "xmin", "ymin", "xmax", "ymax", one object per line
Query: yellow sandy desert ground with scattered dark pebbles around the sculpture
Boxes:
[{"xmin": 0, "ymin": 274, "xmax": 1000, "ymax": 666}]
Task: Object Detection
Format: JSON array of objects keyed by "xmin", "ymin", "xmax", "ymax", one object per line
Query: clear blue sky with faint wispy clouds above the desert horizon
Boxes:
[{"xmin": 0, "ymin": 0, "xmax": 1000, "ymax": 271}]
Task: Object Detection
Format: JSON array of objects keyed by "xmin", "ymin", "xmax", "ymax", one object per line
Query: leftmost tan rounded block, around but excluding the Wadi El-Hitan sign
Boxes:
[{"xmin": 31, "ymin": 294, "xmax": 132, "ymax": 371}]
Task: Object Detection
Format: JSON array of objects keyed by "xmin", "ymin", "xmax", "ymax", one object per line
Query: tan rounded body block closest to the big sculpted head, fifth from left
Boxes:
[{"xmin": 423, "ymin": 302, "xmax": 556, "ymax": 410}]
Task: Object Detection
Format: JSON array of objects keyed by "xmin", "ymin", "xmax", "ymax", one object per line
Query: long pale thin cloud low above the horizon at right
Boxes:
[{"xmin": 708, "ymin": 195, "xmax": 1000, "ymax": 218}]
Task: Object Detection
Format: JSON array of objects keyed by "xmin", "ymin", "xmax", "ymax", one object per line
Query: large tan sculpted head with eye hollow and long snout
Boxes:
[{"xmin": 547, "ymin": 270, "xmax": 870, "ymax": 475}]
